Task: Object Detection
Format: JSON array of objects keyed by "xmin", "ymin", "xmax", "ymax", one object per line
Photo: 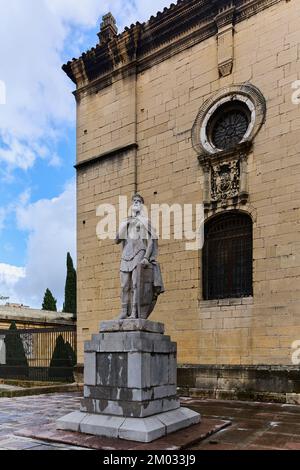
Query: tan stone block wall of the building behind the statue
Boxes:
[{"xmin": 72, "ymin": 0, "xmax": 300, "ymax": 365}]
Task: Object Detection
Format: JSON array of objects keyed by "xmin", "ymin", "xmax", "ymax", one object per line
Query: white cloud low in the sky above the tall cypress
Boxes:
[{"xmin": 0, "ymin": 182, "xmax": 76, "ymax": 308}]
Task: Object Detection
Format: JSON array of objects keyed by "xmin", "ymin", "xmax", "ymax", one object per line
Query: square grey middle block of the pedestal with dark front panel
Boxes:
[{"xmin": 85, "ymin": 330, "xmax": 177, "ymax": 399}]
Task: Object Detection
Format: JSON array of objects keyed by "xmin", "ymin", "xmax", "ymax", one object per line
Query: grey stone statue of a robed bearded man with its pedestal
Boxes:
[{"xmin": 57, "ymin": 194, "xmax": 201, "ymax": 442}]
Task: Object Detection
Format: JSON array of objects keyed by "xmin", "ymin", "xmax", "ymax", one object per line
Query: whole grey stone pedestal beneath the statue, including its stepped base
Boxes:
[{"xmin": 57, "ymin": 319, "xmax": 200, "ymax": 442}]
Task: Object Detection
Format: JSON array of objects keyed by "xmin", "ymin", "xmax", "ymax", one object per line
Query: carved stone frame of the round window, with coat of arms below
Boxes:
[{"xmin": 192, "ymin": 83, "xmax": 266, "ymax": 213}]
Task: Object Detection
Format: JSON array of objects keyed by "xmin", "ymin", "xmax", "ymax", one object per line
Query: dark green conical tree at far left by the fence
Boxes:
[{"xmin": 4, "ymin": 321, "xmax": 28, "ymax": 378}]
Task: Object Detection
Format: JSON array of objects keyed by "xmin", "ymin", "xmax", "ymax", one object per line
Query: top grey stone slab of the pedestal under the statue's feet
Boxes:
[{"xmin": 100, "ymin": 318, "xmax": 165, "ymax": 335}]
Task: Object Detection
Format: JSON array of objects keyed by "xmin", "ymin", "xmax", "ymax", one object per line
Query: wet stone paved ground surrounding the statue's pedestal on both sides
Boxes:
[{"xmin": 0, "ymin": 393, "xmax": 300, "ymax": 451}]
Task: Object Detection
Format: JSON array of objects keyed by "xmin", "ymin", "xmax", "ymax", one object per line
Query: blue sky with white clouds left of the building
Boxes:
[{"xmin": 0, "ymin": 0, "xmax": 171, "ymax": 308}]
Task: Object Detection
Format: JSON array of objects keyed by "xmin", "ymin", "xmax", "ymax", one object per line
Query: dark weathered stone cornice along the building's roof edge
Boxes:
[{"xmin": 63, "ymin": 0, "xmax": 283, "ymax": 93}]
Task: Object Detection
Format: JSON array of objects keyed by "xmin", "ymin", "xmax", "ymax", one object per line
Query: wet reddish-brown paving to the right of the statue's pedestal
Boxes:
[{"xmin": 184, "ymin": 399, "xmax": 300, "ymax": 450}]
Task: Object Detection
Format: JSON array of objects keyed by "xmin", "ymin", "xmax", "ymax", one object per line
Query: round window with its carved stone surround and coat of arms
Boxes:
[{"xmin": 192, "ymin": 84, "xmax": 266, "ymax": 211}]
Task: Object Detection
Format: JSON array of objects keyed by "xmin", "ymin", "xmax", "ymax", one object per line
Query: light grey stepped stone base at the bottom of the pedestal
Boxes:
[{"xmin": 57, "ymin": 408, "xmax": 201, "ymax": 443}]
